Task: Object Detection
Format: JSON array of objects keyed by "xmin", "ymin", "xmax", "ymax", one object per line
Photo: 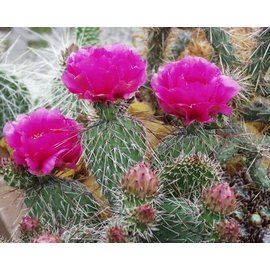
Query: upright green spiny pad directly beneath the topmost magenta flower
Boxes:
[{"xmin": 85, "ymin": 117, "xmax": 146, "ymax": 200}]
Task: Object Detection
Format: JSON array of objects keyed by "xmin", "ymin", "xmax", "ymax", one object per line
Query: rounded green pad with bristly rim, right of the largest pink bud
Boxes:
[{"xmin": 161, "ymin": 154, "xmax": 221, "ymax": 199}]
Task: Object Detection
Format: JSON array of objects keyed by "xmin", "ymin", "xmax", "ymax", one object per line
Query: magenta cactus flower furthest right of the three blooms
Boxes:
[{"xmin": 151, "ymin": 56, "xmax": 240, "ymax": 125}]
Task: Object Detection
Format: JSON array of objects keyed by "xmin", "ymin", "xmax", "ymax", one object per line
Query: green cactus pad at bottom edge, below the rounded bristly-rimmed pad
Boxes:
[{"xmin": 153, "ymin": 198, "xmax": 202, "ymax": 243}]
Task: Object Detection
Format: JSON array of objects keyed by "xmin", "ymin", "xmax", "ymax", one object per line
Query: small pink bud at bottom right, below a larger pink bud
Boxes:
[{"xmin": 217, "ymin": 219, "xmax": 240, "ymax": 243}]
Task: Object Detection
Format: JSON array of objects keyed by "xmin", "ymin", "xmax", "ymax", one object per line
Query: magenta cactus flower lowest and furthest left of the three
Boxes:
[{"xmin": 4, "ymin": 108, "xmax": 82, "ymax": 175}]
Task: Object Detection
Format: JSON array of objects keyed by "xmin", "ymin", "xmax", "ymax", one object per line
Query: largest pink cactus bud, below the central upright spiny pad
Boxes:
[{"xmin": 122, "ymin": 162, "xmax": 158, "ymax": 199}]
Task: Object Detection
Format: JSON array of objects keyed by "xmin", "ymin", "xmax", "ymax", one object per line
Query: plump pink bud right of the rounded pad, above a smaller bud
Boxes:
[{"xmin": 203, "ymin": 183, "xmax": 236, "ymax": 215}]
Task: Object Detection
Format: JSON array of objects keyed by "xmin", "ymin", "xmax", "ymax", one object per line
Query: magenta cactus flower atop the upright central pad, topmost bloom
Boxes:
[{"xmin": 62, "ymin": 44, "xmax": 147, "ymax": 102}]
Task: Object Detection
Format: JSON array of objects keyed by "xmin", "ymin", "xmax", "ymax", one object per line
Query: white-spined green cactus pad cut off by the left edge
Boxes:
[{"xmin": 0, "ymin": 71, "xmax": 30, "ymax": 136}]
